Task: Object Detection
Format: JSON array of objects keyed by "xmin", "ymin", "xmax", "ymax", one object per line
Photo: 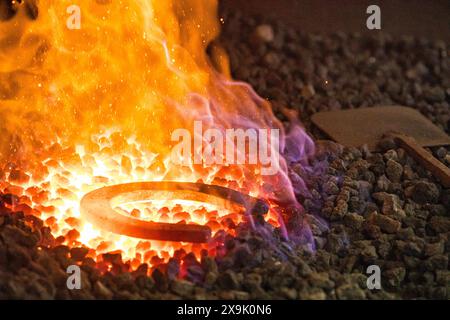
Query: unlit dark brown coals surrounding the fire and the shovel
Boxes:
[{"xmin": 0, "ymin": 10, "xmax": 450, "ymax": 299}]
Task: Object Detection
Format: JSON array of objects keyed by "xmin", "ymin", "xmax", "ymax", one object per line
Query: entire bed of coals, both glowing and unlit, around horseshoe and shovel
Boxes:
[{"xmin": 0, "ymin": 1, "xmax": 450, "ymax": 299}]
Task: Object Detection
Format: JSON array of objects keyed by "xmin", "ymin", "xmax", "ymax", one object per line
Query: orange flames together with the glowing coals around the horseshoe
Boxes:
[{"xmin": 0, "ymin": 0, "xmax": 312, "ymax": 267}]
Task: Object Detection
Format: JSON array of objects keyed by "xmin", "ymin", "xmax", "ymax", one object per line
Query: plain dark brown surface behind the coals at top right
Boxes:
[{"xmin": 219, "ymin": 0, "xmax": 450, "ymax": 41}]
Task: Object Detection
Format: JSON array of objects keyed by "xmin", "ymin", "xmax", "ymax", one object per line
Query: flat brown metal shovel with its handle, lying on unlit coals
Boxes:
[{"xmin": 312, "ymin": 106, "xmax": 450, "ymax": 188}]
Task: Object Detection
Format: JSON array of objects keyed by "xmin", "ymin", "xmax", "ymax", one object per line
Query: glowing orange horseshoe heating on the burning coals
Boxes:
[{"xmin": 80, "ymin": 181, "xmax": 269, "ymax": 243}]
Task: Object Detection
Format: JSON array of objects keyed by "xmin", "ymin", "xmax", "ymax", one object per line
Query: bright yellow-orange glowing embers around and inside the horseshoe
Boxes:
[{"xmin": 2, "ymin": 134, "xmax": 277, "ymax": 266}]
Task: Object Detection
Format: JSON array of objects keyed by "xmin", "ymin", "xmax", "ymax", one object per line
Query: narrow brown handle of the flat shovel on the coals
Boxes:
[{"xmin": 392, "ymin": 133, "xmax": 450, "ymax": 188}]
